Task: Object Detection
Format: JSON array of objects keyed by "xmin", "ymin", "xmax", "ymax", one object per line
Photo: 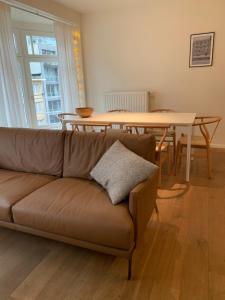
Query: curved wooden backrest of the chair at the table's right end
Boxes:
[{"xmin": 193, "ymin": 116, "xmax": 222, "ymax": 145}]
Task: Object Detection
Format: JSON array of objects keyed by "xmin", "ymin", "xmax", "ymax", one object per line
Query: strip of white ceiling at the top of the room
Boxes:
[{"xmin": 51, "ymin": 0, "xmax": 142, "ymax": 13}]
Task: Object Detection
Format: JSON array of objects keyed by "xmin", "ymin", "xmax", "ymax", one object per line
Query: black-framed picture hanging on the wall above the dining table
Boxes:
[{"xmin": 189, "ymin": 32, "xmax": 215, "ymax": 67}]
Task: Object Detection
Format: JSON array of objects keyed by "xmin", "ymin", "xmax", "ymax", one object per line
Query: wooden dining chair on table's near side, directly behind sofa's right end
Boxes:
[{"xmin": 125, "ymin": 124, "xmax": 171, "ymax": 185}]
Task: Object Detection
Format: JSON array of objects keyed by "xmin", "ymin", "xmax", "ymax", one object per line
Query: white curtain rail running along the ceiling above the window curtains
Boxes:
[{"xmin": 0, "ymin": 0, "xmax": 78, "ymax": 26}]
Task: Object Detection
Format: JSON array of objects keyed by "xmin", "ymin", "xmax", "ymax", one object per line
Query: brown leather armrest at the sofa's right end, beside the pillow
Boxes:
[{"xmin": 129, "ymin": 169, "xmax": 159, "ymax": 242}]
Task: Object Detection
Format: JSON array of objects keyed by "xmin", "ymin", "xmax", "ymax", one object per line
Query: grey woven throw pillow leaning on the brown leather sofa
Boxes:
[{"xmin": 90, "ymin": 141, "xmax": 158, "ymax": 205}]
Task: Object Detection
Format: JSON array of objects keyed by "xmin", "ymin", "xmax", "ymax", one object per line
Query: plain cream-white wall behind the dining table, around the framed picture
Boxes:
[{"xmin": 81, "ymin": 0, "xmax": 225, "ymax": 146}]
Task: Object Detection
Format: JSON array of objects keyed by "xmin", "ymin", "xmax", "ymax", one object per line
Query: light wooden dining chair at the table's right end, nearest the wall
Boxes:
[{"xmin": 177, "ymin": 116, "xmax": 221, "ymax": 178}]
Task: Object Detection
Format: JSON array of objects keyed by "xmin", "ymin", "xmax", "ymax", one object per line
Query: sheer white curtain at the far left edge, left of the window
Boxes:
[{"xmin": 0, "ymin": 2, "xmax": 26, "ymax": 127}]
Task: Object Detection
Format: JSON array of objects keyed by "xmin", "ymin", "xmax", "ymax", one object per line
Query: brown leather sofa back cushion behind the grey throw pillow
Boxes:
[{"xmin": 63, "ymin": 132, "xmax": 155, "ymax": 179}]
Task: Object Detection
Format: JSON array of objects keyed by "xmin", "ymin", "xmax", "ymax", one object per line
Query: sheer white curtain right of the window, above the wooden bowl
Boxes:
[{"xmin": 54, "ymin": 22, "xmax": 85, "ymax": 112}]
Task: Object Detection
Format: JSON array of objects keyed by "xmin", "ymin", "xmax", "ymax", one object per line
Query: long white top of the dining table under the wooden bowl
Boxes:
[{"xmin": 71, "ymin": 112, "xmax": 196, "ymax": 126}]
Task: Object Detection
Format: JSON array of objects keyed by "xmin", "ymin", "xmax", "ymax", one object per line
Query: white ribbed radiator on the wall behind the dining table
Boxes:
[{"xmin": 105, "ymin": 91, "xmax": 150, "ymax": 112}]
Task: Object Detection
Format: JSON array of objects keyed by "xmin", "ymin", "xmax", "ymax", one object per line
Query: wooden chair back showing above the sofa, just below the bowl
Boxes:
[{"xmin": 71, "ymin": 121, "xmax": 112, "ymax": 132}]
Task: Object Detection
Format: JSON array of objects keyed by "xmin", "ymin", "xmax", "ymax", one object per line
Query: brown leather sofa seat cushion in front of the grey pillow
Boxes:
[{"xmin": 13, "ymin": 178, "xmax": 134, "ymax": 250}]
